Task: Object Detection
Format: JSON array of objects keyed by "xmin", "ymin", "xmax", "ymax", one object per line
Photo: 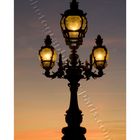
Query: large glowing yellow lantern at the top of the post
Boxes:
[{"xmin": 60, "ymin": 0, "xmax": 87, "ymax": 49}]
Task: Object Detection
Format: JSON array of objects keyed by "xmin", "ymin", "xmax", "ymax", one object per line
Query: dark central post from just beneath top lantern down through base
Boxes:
[{"xmin": 62, "ymin": 51, "xmax": 86, "ymax": 140}]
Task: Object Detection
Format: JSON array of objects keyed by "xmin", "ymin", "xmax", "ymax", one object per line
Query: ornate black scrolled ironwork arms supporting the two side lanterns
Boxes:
[{"xmin": 42, "ymin": 35, "xmax": 107, "ymax": 82}]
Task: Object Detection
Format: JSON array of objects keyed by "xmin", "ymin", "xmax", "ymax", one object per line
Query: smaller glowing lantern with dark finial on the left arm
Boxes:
[{"xmin": 39, "ymin": 36, "xmax": 57, "ymax": 70}]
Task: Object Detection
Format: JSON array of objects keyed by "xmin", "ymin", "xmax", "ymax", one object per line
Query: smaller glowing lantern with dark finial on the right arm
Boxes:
[{"xmin": 92, "ymin": 35, "xmax": 108, "ymax": 69}]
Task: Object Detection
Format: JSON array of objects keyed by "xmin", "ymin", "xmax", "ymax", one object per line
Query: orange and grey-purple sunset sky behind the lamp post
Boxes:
[{"xmin": 15, "ymin": 0, "xmax": 126, "ymax": 140}]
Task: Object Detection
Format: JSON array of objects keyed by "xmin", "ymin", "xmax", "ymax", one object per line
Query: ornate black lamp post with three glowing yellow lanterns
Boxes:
[{"xmin": 39, "ymin": 0, "xmax": 108, "ymax": 140}]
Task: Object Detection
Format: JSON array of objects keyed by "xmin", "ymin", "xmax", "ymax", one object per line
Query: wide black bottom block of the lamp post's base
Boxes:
[{"xmin": 62, "ymin": 127, "xmax": 86, "ymax": 140}]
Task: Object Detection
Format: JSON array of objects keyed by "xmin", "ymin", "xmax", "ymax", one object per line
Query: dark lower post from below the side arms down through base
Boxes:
[{"xmin": 62, "ymin": 83, "xmax": 86, "ymax": 140}]
